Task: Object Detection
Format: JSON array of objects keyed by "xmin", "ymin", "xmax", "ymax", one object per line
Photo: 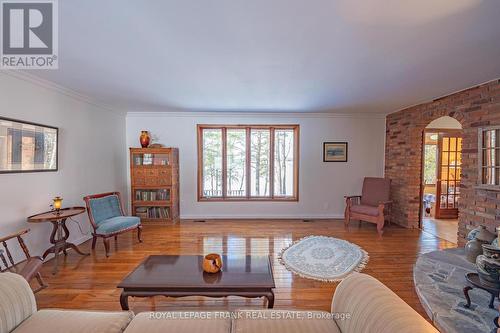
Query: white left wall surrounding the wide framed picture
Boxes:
[{"xmin": 0, "ymin": 72, "xmax": 127, "ymax": 256}]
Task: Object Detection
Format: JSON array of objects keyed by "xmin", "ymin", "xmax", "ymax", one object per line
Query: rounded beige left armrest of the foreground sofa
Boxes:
[{"xmin": 0, "ymin": 272, "xmax": 36, "ymax": 333}]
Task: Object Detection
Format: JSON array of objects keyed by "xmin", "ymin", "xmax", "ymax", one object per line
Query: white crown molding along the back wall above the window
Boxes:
[{"xmin": 127, "ymin": 111, "xmax": 386, "ymax": 119}]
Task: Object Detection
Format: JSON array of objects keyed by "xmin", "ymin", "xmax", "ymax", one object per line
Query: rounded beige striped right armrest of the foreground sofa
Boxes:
[{"xmin": 332, "ymin": 273, "xmax": 439, "ymax": 333}]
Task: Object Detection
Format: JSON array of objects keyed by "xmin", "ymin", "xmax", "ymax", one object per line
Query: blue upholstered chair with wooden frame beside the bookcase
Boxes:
[{"xmin": 83, "ymin": 192, "xmax": 142, "ymax": 257}]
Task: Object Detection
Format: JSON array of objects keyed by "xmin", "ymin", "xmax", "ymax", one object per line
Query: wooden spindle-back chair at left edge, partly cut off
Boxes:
[{"xmin": 0, "ymin": 229, "xmax": 47, "ymax": 293}]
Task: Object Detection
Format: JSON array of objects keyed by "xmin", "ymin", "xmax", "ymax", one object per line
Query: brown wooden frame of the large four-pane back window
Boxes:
[{"xmin": 197, "ymin": 124, "xmax": 300, "ymax": 201}]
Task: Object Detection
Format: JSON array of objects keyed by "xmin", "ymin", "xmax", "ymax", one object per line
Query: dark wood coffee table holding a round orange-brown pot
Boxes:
[{"xmin": 118, "ymin": 255, "xmax": 275, "ymax": 310}]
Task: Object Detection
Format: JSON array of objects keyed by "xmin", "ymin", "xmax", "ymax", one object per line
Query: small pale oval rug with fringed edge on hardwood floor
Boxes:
[{"xmin": 278, "ymin": 236, "xmax": 369, "ymax": 282}]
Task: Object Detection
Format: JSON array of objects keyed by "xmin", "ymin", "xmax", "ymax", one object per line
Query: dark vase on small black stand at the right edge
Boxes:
[{"xmin": 476, "ymin": 244, "xmax": 500, "ymax": 288}]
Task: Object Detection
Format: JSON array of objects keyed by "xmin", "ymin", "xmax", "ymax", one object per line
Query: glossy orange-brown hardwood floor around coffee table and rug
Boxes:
[{"xmin": 36, "ymin": 220, "xmax": 456, "ymax": 318}]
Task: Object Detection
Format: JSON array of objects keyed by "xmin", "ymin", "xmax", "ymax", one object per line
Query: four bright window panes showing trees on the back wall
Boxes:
[{"xmin": 199, "ymin": 125, "xmax": 298, "ymax": 199}]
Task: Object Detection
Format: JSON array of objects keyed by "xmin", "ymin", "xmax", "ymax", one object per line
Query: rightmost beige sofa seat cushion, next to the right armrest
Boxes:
[{"xmin": 231, "ymin": 310, "xmax": 340, "ymax": 333}]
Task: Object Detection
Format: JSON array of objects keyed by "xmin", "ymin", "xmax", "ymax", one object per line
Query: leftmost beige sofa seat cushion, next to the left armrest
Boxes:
[{"xmin": 13, "ymin": 310, "xmax": 134, "ymax": 333}]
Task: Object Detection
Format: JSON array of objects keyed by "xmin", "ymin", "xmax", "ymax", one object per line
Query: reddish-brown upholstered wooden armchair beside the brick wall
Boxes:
[{"xmin": 345, "ymin": 177, "xmax": 392, "ymax": 235}]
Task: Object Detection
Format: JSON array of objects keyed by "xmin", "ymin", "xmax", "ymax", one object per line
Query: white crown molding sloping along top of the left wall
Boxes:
[{"xmin": 0, "ymin": 69, "xmax": 123, "ymax": 114}]
